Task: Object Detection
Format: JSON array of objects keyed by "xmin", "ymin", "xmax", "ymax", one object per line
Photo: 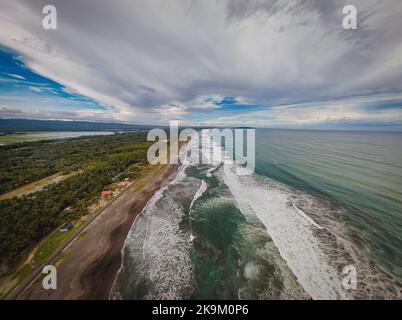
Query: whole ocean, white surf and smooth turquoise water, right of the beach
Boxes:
[{"xmin": 113, "ymin": 129, "xmax": 402, "ymax": 299}]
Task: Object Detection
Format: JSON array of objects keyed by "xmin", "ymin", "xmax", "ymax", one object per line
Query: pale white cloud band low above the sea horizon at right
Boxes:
[{"xmin": 192, "ymin": 95, "xmax": 402, "ymax": 128}]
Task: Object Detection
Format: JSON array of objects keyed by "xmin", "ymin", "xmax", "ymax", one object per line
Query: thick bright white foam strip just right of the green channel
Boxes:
[{"xmin": 223, "ymin": 156, "xmax": 352, "ymax": 299}]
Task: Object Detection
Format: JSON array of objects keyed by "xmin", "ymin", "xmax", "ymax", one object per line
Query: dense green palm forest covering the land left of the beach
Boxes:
[{"xmin": 0, "ymin": 132, "xmax": 151, "ymax": 265}]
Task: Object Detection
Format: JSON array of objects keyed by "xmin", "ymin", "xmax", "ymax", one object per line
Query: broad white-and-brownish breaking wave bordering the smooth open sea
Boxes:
[{"xmin": 223, "ymin": 162, "xmax": 402, "ymax": 299}]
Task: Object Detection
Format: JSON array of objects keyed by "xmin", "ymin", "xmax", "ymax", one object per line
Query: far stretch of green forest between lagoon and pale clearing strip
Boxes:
[{"xmin": 0, "ymin": 132, "xmax": 146, "ymax": 195}]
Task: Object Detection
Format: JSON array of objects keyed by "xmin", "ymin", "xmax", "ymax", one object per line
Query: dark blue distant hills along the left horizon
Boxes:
[{"xmin": 0, "ymin": 119, "xmax": 149, "ymax": 133}]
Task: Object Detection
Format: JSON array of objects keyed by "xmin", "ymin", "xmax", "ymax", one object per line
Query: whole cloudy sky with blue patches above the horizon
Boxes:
[{"xmin": 0, "ymin": 0, "xmax": 402, "ymax": 130}]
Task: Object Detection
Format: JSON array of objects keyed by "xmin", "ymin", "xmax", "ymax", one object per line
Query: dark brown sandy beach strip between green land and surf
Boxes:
[{"xmin": 22, "ymin": 165, "xmax": 178, "ymax": 300}]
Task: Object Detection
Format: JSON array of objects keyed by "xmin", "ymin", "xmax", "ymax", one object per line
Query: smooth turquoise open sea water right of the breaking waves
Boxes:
[{"xmin": 256, "ymin": 130, "xmax": 402, "ymax": 279}]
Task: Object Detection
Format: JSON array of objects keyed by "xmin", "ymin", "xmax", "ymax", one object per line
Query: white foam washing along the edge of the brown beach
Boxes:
[{"xmin": 114, "ymin": 140, "xmax": 207, "ymax": 299}]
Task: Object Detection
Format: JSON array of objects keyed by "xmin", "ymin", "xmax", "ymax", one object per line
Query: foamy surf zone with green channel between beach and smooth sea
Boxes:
[{"xmin": 115, "ymin": 131, "xmax": 402, "ymax": 299}]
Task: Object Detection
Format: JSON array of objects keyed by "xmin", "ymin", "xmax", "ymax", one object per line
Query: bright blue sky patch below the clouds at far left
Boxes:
[{"xmin": 0, "ymin": 47, "xmax": 106, "ymax": 110}]
